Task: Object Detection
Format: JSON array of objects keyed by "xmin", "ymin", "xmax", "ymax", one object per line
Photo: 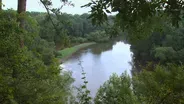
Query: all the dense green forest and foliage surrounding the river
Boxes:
[{"xmin": 0, "ymin": 0, "xmax": 184, "ymax": 104}]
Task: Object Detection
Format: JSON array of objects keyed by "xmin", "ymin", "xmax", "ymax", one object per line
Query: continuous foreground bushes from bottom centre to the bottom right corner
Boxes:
[{"xmin": 94, "ymin": 64, "xmax": 184, "ymax": 104}]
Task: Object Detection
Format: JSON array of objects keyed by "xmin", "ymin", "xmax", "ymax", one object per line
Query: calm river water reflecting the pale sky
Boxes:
[{"xmin": 62, "ymin": 42, "xmax": 132, "ymax": 97}]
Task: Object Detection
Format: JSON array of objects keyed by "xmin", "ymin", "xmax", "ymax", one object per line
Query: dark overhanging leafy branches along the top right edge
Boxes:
[{"xmin": 82, "ymin": 0, "xmax": 184, "ymax": 27}]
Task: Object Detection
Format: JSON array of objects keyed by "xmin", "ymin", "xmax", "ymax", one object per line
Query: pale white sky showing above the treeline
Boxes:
[{"xmin": 2, "ymin": 0, "xmax": 90, "ymax": 14}]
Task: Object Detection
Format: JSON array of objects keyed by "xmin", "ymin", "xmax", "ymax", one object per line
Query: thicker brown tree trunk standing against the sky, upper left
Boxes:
[{"xmin": 17, "ymin": 0, "xmax": 26, "ymax": 48}]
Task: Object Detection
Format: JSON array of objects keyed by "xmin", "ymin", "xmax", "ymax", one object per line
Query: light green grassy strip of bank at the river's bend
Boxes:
[{"xmin": 57, "ymin": 42, "xmax": 96, "ymax": 60}]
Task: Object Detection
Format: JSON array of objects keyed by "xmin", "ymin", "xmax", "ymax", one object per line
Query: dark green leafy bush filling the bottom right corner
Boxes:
[{"xmin": 133, "ymin": 64, "xmax": 184, "ymax": 104}]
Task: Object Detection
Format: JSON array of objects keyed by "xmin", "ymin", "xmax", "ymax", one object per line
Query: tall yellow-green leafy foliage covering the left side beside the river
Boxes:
[{"xmin": 0, "ymin": 10, "xmax": 73, "ymax": 104}]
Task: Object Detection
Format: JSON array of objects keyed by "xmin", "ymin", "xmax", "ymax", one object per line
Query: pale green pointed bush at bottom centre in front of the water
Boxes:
[{"xmin": 94, "ymin": 73, "xmax": 138, "ymax": 104}]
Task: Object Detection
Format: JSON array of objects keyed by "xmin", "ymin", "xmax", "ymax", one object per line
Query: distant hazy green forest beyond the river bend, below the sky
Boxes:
[{"xmin": 27, "ymin": 12, "xmax": 119, "ymax": 50}]
